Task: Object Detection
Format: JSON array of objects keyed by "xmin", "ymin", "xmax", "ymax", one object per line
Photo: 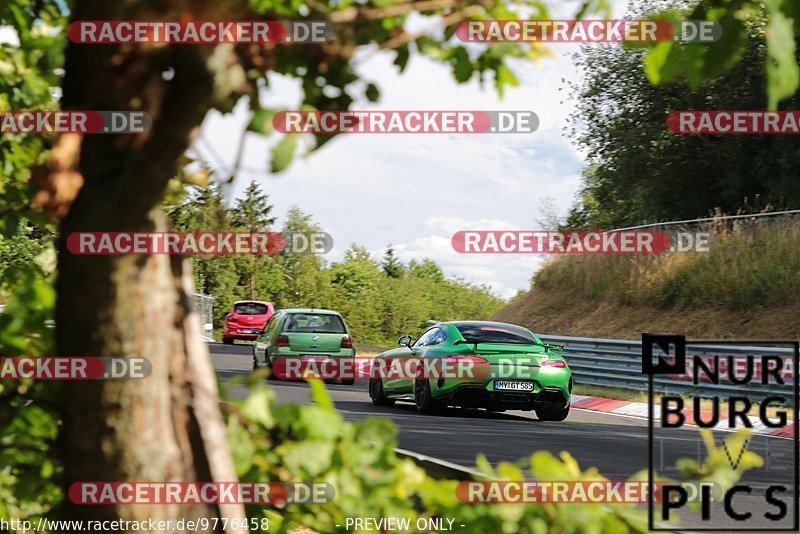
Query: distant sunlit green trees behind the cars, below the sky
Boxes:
[{"xmin": 166, "ymin": 183, "xmax": 504, "ymax": 344}]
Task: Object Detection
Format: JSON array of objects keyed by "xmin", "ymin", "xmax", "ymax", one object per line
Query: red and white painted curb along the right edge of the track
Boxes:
[{"xmin": 572, "ymin": 395, "xmax": 794, "ymax": 439}]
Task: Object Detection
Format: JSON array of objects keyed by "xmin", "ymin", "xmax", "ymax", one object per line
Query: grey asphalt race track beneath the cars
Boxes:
[{"xmin": 209, "ymin": 343, "xmax": 794, "ymax": 530}]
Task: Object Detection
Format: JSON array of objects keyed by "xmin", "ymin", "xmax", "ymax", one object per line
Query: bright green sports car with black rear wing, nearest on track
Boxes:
[{"xmin": 369, "ymin": 321, "xmax": 573, "ymax": 421}]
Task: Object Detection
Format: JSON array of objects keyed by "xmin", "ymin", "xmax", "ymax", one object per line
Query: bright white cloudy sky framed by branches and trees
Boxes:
[{"xmin": 195, "ymin": 2, "xmax": 636, "ymax": 298}]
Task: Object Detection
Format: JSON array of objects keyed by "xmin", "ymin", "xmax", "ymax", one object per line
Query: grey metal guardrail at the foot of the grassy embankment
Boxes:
[{"xmin": 539, "ymin": 335, "xmax": 797, "ymax": 399}]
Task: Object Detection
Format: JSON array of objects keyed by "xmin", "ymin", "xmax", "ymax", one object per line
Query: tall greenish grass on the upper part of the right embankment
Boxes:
[{"xmin": 533, "ymin": 219, "xmax": 800, "ymax": 308}]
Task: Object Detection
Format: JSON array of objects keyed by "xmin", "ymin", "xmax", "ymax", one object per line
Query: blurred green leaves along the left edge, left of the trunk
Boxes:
[{"xmin": 0, "ymin": 0, "xmax": 66, "ymax": 519}]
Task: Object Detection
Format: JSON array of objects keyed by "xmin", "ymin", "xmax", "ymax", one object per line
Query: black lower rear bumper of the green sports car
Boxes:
[{"xmin": 436, "ymin": 385, "xmax": 570, "ymax": 410}]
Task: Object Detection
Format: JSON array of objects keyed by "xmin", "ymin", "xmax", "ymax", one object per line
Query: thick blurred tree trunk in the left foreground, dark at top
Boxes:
[{"xmin": 51, "ymin": 0, "xmax": 244, "ymax": 532}]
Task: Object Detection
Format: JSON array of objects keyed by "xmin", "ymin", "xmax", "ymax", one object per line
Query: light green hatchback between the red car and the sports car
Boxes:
[{"xmin": 253, "ymin": 309, "xmax": 356, "ymax": 385}]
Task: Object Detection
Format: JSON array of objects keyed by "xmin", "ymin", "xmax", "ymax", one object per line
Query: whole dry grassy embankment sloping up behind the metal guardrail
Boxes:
[{"xmin": 493, "ymin": 219, "xmax": 800, "ymax": 400}]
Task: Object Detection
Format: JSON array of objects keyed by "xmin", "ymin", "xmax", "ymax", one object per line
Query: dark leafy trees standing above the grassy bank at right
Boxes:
[{"xmin": 566, "ymin": 4, "xmax": 800, "ymax": 229}]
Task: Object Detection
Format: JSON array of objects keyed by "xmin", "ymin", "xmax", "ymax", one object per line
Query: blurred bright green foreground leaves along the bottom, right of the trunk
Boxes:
[{"xmin": 227, "ymin": 374, "xmax": 761, "ymax": 534}]
